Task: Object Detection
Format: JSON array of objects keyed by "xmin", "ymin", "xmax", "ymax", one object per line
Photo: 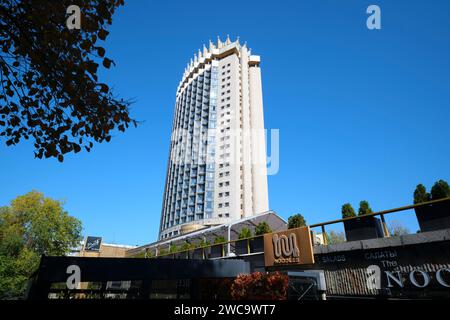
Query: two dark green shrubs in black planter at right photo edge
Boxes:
[{"xmin": 414, "ymin": 180, "xmax": 450, "ymax": 232}]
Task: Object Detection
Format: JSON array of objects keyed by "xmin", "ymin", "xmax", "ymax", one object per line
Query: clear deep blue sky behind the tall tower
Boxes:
[{"xmin": 0, "ymin": 0, "xmax": 450, "ymax": 244}]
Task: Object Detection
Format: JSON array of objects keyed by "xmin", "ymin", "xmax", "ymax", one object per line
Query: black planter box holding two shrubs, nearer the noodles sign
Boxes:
[{"xmin": 344, "ymin": 216, "xmax": 384, "ymax": 241}]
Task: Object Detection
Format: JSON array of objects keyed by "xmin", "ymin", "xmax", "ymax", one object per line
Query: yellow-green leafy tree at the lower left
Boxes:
[{"xmin": 0, "ymin": 191, "xmax": 81, "ymax": 299}]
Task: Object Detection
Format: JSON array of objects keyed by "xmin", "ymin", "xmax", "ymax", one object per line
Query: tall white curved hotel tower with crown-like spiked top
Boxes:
[{"xmin": 159, "ymin": 38, "xmax": 269, "ymax": 240}]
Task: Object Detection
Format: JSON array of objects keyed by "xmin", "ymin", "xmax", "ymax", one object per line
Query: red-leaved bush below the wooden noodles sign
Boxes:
[{"xmin": 231, "ymin": 272, "xmax": 288, "ymax": 300}]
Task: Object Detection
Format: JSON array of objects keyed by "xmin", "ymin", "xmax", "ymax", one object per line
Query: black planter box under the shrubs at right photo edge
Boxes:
[{"xmin": 414, "ymin": 201, "xmax": 450, "ymax": 232}]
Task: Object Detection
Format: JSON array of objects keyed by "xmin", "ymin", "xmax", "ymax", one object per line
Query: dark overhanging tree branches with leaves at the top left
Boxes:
[{"xmin": 0, "ymin": 0, "xmax": 137, "ymax": 161}]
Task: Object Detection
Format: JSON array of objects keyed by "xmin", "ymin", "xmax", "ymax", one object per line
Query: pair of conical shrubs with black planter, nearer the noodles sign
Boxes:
[{"xmin": 342, "ymin": 200, "xmax": 384, "ymax": 241}]
